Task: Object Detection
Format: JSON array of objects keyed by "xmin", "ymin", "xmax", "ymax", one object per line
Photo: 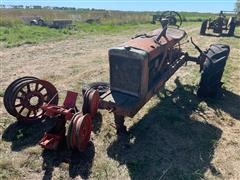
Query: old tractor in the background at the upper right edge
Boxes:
[{"xmin": 200, "ymin": 11, "xmax": 237, "ymax": 36}]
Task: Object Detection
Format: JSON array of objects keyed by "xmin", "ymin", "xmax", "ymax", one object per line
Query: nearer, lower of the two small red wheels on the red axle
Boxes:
[{"xmin": 67, "ymin": 113, "xmax": 92, "ymax": 151}]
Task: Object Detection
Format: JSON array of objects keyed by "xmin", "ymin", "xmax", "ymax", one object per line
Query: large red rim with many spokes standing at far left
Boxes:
[{"xmin": 5, "ymin": 79, "xmax": 58, "ymax": 123}]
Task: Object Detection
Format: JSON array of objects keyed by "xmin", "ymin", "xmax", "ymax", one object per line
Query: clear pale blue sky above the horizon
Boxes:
[{"xmin": 0, "ymin": 0, "xmax": 236, "ymax": 12}]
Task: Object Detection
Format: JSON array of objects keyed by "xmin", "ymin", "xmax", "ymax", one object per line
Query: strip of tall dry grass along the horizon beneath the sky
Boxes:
[{"xmin": 0, "ymin": 9, "xmax": 214, "ymax": 26}]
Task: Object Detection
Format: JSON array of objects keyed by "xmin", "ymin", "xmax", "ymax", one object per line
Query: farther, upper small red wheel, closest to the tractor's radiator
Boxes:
[{"xmin": 82, "ymin": 89, "xmax": 100, "ymax": 118}]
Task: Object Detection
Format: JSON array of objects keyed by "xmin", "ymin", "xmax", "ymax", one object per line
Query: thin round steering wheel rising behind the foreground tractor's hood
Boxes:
[{"xmin": 159, "ymin": 11, "xmax": 182, "ymax": 28}]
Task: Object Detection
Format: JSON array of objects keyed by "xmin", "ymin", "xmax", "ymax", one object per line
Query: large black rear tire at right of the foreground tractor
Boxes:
[{"xmin": 197, "ymin": 44, "xmax": 230, "ymax": 98}]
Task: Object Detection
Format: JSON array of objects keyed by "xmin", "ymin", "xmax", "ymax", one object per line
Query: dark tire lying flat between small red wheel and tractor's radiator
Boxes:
[{"xmin": 82, "ymin": 82, "xmax": 110, "ymax": 96}]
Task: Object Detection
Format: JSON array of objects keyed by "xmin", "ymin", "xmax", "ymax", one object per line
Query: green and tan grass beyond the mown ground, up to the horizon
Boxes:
[{"xmin": 0, "ymin": 9, "xmax": 218, "ymax": 48}]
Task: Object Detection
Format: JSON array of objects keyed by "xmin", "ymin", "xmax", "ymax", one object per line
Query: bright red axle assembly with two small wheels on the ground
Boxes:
[{"xmin": 39, "ymin": 90, "xmax": 94, "ymax": 151}]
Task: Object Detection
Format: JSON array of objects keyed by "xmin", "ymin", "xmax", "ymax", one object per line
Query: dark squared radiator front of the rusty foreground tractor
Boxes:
[{"xmin": 109, "ymin": 48, "xmax": 148, "ymax": 96}]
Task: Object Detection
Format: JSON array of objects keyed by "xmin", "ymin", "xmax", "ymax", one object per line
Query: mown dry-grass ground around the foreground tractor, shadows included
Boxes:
[{"xmin": 0, "ymin": 8, "xmax": 240, "ymax": 180}]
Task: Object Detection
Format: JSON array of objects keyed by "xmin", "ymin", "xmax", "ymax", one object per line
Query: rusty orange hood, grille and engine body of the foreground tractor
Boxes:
[{"xmin": 109, "ymin": 28, "xmax": 186, "ymax": 98}]
